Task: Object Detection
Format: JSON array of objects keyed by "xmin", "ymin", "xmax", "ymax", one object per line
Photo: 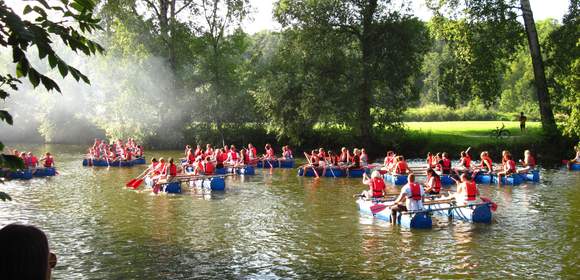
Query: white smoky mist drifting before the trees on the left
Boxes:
[{"xmin": 0, "ymin": 37, "xmax": 183, "ymax": 144}]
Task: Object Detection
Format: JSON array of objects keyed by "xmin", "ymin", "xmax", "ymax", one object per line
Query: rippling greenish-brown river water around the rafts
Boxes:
[{"xmin": 0, "ymin": 145, "xmax": 580, "ymax": 279}]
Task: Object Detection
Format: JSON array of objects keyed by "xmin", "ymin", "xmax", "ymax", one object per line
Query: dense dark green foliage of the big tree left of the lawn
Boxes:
[{"xmin": 269, "ymin": 0, "xmax": 428, "ymax": 142}]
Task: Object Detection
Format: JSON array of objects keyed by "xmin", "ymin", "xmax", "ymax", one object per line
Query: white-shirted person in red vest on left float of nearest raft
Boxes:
[{"xmin": 391, "ymin": 174, "xmax": 425, "ymax": 224}]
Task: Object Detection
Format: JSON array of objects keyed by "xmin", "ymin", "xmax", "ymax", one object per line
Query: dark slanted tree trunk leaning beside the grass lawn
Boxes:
[{"xmin": 520, "ymin": 0, "xmax": 556, "ymax": 134}]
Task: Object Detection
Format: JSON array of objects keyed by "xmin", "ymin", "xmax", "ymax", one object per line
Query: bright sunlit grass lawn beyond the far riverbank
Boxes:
[{"xmin": 405, "ymin": 121, "xmax": 542, "ymax": 146}]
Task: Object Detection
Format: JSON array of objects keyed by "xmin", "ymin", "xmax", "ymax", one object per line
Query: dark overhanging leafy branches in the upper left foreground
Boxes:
[{"xmin": 0, "ymin": 0, "xmax": 104, "ymax": 201}]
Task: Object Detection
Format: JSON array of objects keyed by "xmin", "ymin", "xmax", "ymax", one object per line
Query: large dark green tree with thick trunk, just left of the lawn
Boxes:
[{"xmin": 275, "ymin": 0, "xmax": 428, "ymax": 146}]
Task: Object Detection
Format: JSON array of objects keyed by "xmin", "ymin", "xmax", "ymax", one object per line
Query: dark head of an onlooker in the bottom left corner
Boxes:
[{"xmin": 0, "ymin": 224, "xmax": 50, "ymax": 280}]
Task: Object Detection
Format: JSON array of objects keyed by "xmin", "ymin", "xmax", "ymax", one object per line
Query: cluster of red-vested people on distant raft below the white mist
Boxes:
[{"xmin": 87, "ymin": 138, "xmax": 144, "ymax": 161}]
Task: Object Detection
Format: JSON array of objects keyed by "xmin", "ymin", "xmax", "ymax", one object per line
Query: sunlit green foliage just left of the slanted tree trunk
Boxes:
[{"xmin": 427, "ymin": 0, "xmax": 524, "ymax": 107}]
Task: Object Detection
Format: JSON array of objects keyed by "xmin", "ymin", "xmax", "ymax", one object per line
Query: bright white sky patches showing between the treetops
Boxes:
[{"xmin": 243, "ymin": 0, "xmax": 570, "ymax": 34}]
